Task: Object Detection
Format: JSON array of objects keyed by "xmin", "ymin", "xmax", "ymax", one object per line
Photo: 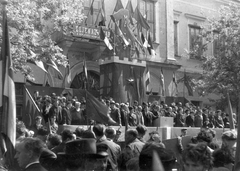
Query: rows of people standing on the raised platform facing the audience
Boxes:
[{"xmin": 32, "ymin": 90, "xmax": 236, "ymax": 132}]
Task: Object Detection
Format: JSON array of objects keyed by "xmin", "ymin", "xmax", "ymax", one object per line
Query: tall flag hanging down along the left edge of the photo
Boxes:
[{"xmin": 0, "ymin": 4, "xmax": 16, "ymax": 169}]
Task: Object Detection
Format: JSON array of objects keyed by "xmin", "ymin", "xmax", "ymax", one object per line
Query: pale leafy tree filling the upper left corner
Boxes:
[{"xmin": 3, "ymin": 0, "xmax": 85, "ymax": 79}]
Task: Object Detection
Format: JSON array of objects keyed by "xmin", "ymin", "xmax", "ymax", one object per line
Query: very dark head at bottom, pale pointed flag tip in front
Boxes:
[{"xmin": 139, "ymin": 142, "xmax": 176, "ymax": 171}]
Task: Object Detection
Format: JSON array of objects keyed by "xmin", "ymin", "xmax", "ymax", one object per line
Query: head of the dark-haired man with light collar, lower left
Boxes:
[{"xmin": 14, "ymin": 138, "xmax": 46, "ymax": 168}]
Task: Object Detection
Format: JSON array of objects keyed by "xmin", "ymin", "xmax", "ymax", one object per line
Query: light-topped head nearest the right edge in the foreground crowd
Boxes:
[{"xmin": 222, "ymin": 130, "xmax": 237, "ymax": 157}]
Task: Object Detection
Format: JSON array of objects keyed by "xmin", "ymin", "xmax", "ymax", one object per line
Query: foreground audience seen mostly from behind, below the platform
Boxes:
[{"xmin": 0, "ymin": 120, "xmax": 240, "ymax": 171}]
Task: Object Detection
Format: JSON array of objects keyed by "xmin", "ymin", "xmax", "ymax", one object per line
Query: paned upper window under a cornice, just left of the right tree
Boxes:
[{"xmin": 189, "ymin": 25, "xmax": 203, "ymax": 59}]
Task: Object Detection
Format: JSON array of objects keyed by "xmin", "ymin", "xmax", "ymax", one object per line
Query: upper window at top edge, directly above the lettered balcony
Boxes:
[{"xmin": 83, "ymin": 0, "xmax": 101, "ymax": 26}]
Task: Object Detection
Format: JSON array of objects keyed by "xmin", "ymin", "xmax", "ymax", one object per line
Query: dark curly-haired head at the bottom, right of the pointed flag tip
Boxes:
[{"xmin": 182, "ymin": 143, "xmax": 213, "ymax": 171}]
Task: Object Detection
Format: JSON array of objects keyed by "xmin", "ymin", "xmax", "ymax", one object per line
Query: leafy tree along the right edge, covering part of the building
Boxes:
[{"xmin": 190, "ymin": 4, "xmax": 240, "ymax": 105}]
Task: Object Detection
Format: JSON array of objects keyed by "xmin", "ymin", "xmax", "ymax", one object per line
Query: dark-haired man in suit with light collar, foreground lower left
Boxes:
[{"xmin": 14, "ymin": 138, "xmax": 47, "ymax": 171}]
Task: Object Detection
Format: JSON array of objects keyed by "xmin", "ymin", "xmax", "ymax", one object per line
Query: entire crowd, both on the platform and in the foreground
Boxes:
[{"xmin": 0, "ymin": 93, "xmax": 237, "ymax": 171}]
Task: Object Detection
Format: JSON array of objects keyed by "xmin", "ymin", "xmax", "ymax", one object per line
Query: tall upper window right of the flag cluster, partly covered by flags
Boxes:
[{"xmin": 139, "ymin": 0, "xmax": 155, "ymax": 41}]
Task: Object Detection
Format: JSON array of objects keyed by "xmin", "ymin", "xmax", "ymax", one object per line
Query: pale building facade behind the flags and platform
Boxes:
[{"xmin": 14, "ymin": 0, "xmax": 237, "ymax": 111}]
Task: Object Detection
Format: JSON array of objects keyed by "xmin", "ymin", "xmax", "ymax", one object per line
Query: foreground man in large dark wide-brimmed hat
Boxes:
[{"xmin": 58, "ymin": 138, "xmax": 108, "ymax": 171}]
